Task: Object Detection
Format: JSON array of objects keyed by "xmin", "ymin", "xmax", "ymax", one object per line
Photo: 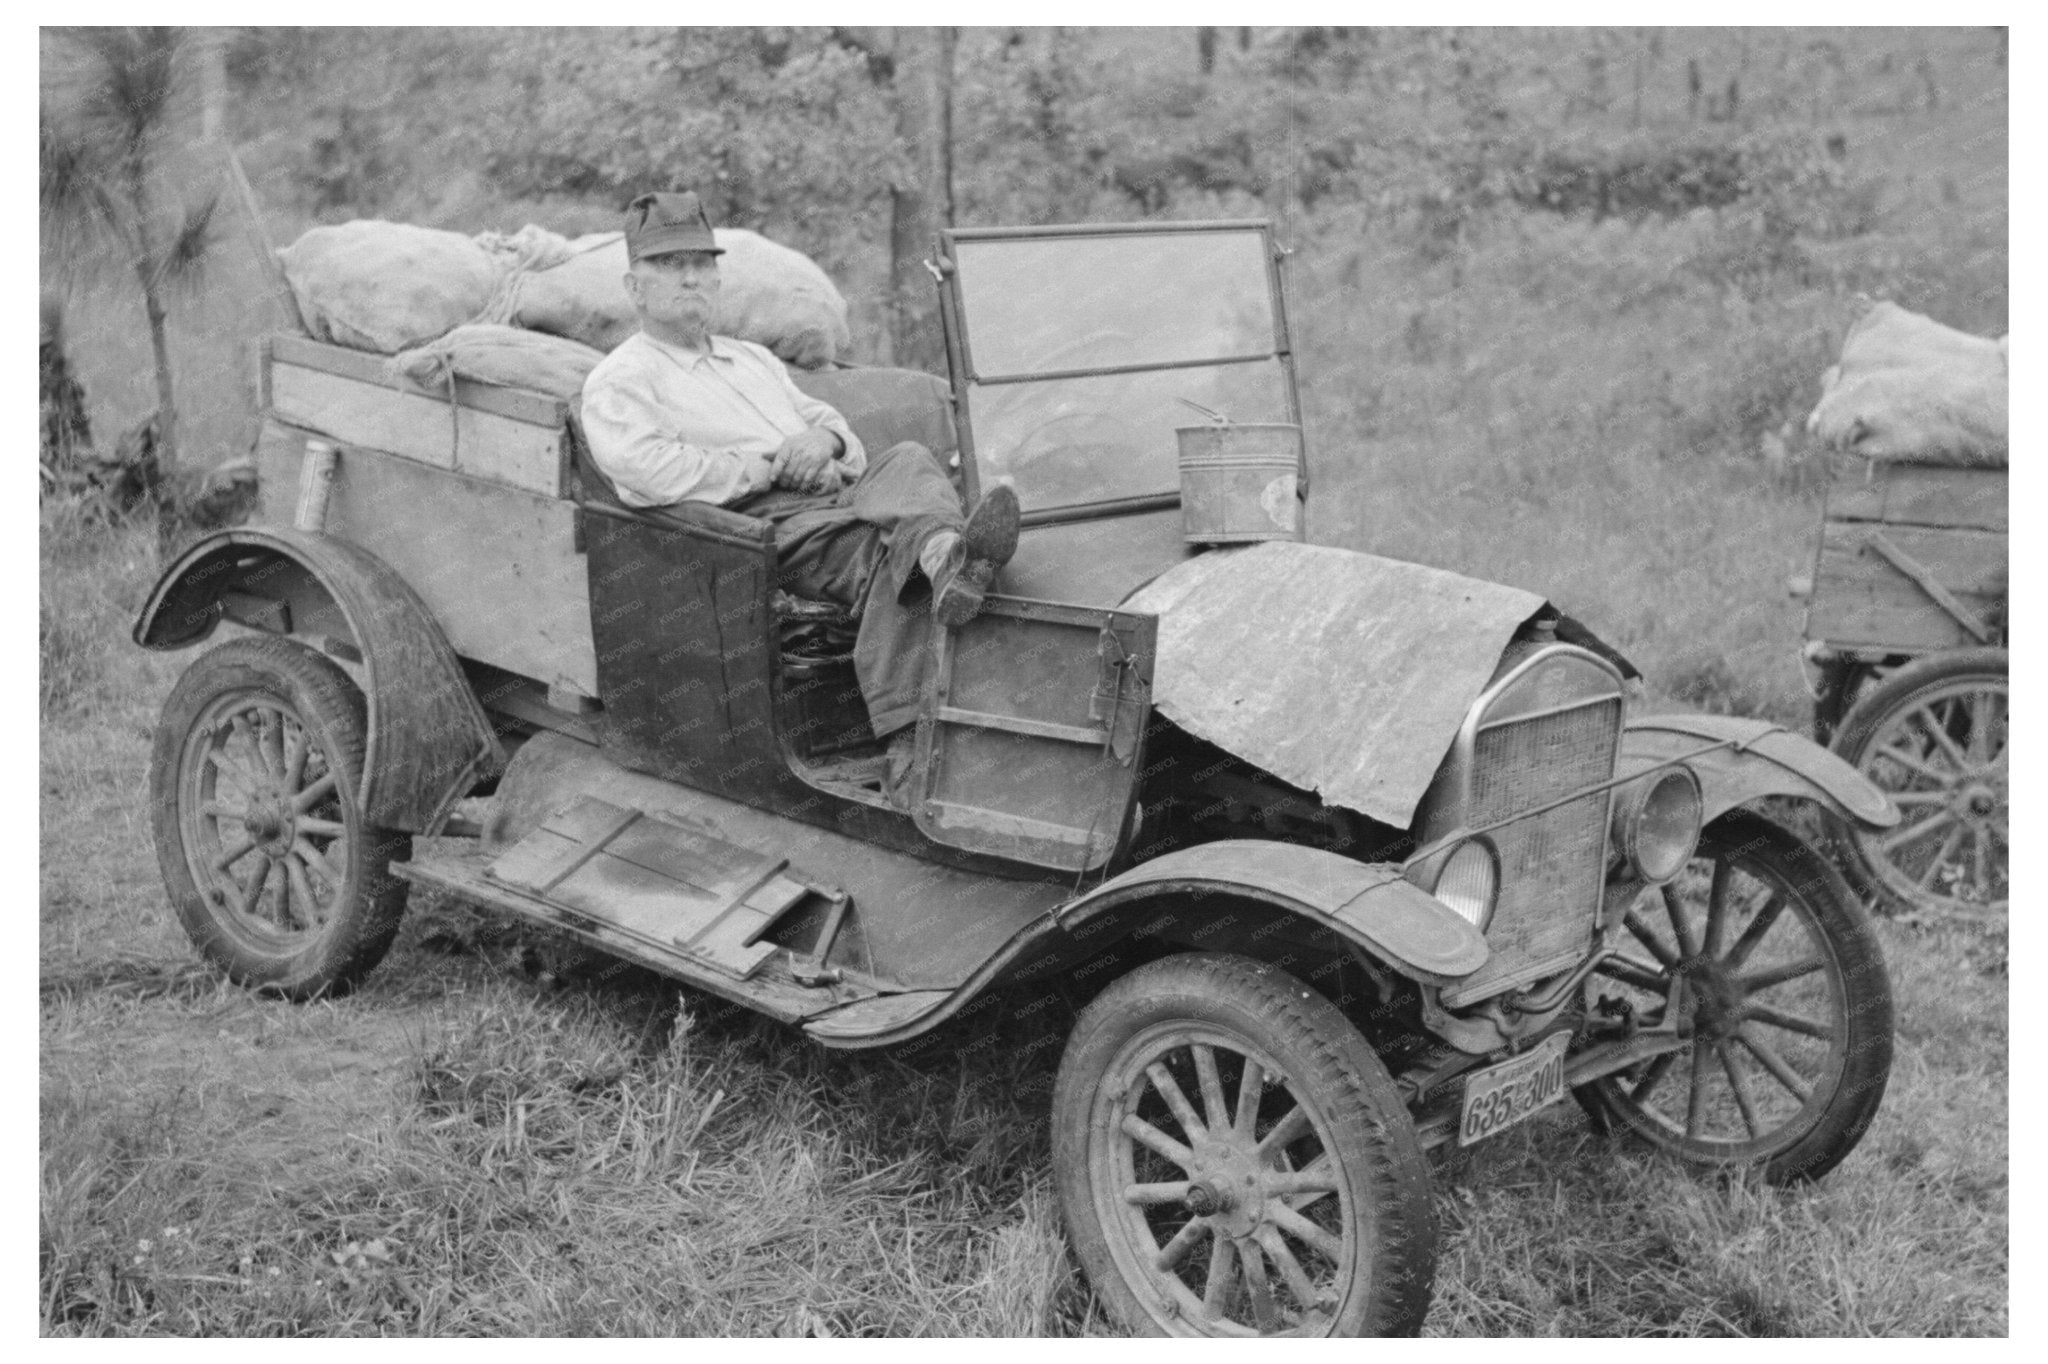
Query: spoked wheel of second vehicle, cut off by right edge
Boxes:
[{"xmin": 1831, "ymin": 649, "xmax": 2009, "ymax": 920}]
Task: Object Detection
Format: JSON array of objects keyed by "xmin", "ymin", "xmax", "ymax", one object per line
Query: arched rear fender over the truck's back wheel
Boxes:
[{"xmin": 135, "ymin": 526, "xmax": 504, "ymax": 834}]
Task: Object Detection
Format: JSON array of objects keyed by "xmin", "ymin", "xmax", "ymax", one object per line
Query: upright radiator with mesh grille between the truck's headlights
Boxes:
[{"xmin": 1444, "ymin": 696, "xmax": 1622, "ymax": 1006}]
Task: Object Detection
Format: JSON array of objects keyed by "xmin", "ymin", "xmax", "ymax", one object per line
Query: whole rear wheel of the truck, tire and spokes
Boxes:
[{"xmin": 150, "ymin": 637, "xmax": 412, "ymax": 999}]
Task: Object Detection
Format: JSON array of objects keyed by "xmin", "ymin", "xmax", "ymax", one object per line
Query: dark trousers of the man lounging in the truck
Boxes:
[{"xmin": 733, "ymin": 440, "xmax": 967, "ymax": 737}]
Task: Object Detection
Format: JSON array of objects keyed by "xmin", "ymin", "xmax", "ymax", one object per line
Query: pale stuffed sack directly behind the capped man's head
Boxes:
[{"xmin": 514, "ymin": 227, "xmax": 852, "ymax": 369}]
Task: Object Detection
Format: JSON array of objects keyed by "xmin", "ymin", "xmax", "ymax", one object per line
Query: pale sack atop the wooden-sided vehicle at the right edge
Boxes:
[{"xmin": 1806, "ymin": 303, "xmax": 2007, "ymax": 469}]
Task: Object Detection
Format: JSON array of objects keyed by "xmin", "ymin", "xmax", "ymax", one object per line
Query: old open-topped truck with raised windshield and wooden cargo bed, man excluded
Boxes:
[{"xmin": 135, "ymin": 223, "xmax": 1898, "ymax": 1333}]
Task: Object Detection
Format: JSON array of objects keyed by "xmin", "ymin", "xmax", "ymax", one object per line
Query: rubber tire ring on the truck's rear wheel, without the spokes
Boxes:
[{"xmin": 150, "ymin": 635, "xmax": 412, "ymax": 999}]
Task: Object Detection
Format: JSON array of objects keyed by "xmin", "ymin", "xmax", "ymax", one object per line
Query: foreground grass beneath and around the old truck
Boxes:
[{"xmin": 39, "ymin": 456, "xmax": 2009, "ymax": 1335}]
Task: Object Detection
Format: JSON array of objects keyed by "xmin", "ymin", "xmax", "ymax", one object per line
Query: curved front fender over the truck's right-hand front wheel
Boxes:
[{"xmin": 1616, "ymin": 715, "xmax": 1898, "ymax": 829}]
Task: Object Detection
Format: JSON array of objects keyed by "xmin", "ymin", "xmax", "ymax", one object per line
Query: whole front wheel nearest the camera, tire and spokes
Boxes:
[{"xmin": 1053, "ymin": 954, "xmax": 1436, "ymax": 1335}]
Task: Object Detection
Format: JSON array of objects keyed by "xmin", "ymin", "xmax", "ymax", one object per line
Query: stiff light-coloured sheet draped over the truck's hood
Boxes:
[{"xmin": 1124, "ymin": 541, "xmax": 1544, "ymax": 829}]
